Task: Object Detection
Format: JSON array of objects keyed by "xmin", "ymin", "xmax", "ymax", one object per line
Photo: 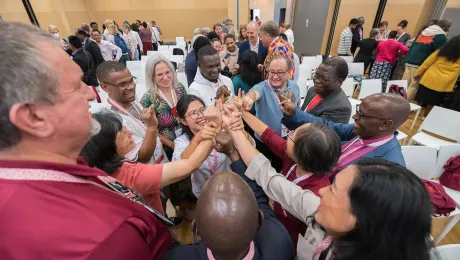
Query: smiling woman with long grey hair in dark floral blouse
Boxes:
[{"xmin": 141, "ymin": 55, "xmax": 187, "ymax": 159}]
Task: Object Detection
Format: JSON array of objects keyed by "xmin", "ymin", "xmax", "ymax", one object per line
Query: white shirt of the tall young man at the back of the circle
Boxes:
[{"xmin": 187, "ymin": 68, "xmax": 234, "ymax": 107}]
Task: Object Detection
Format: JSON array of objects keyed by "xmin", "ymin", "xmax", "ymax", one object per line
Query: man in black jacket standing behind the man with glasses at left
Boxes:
[{"xmin": 69, "ymin": 35, "xmax": 99, "ymax": 86}]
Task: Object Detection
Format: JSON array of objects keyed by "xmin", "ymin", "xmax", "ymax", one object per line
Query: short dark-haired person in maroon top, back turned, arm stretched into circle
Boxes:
[{"xmin": 243, "ymin": 108, "xmax": 342, "ymax": 245}]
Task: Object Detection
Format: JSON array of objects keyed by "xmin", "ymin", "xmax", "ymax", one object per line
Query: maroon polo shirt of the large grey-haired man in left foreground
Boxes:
[{"xmin": 0, "ymin": 157, "xmax": 171, "ymax": 260}]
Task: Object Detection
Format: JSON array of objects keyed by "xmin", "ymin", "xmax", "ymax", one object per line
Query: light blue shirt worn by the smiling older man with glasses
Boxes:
[{"xmin": 252, "ymin": 80, "xmax": 300, "ymax": 140}]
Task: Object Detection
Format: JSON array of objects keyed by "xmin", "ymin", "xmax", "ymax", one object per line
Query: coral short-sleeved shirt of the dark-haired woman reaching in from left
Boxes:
[{"xmin": 112, "ymin": 162, "xmax": 164, "ymax": 214}]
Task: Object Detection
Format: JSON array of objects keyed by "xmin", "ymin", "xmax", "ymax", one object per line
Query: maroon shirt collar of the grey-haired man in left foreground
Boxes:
[{"xmin": 0, "ymin": 157, "xmax": 107, "ymax": 180}]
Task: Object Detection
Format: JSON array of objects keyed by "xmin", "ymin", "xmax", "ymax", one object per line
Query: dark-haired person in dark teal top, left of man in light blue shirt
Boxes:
[{"xmin": 232, "ymin": 51, "xmax": 262, "ymax": 110}]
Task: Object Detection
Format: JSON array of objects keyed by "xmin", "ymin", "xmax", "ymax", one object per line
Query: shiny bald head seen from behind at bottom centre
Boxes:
[{"xmin": 196, "ymin": 172, "xmax": 261, "ymax": 259}]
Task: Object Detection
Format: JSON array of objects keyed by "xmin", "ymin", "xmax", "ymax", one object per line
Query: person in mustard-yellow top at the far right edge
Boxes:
[{"xmin": 414, "ymin": 35, "xmax": 460, "ymax": 116}]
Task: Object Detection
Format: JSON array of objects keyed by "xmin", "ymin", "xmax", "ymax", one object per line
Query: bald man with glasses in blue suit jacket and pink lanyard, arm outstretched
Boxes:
[{"xmin": 281, "ymin": 93, "xmax": 410, "ymax": 180}]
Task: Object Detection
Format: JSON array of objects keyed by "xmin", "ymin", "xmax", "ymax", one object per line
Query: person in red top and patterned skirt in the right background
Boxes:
[{"xmin": 369, "ymin": 31, "xmax": 409, "ymax": 93}]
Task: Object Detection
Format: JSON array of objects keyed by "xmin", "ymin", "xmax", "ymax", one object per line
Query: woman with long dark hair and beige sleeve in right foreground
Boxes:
[{"xmin": 228, "ymin": 114, "xmax": 432, "ymax": 260}]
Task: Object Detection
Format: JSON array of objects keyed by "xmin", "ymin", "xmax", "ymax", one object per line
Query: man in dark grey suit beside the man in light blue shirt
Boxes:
[{"xmin": 302, "ymin": 57, "xmax": 351, "ymax": 124}]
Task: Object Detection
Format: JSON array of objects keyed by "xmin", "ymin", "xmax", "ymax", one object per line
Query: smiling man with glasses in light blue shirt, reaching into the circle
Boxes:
[{"xmin": 243, "ymin": 56, "xmax": 300, "ymax": 171}]
